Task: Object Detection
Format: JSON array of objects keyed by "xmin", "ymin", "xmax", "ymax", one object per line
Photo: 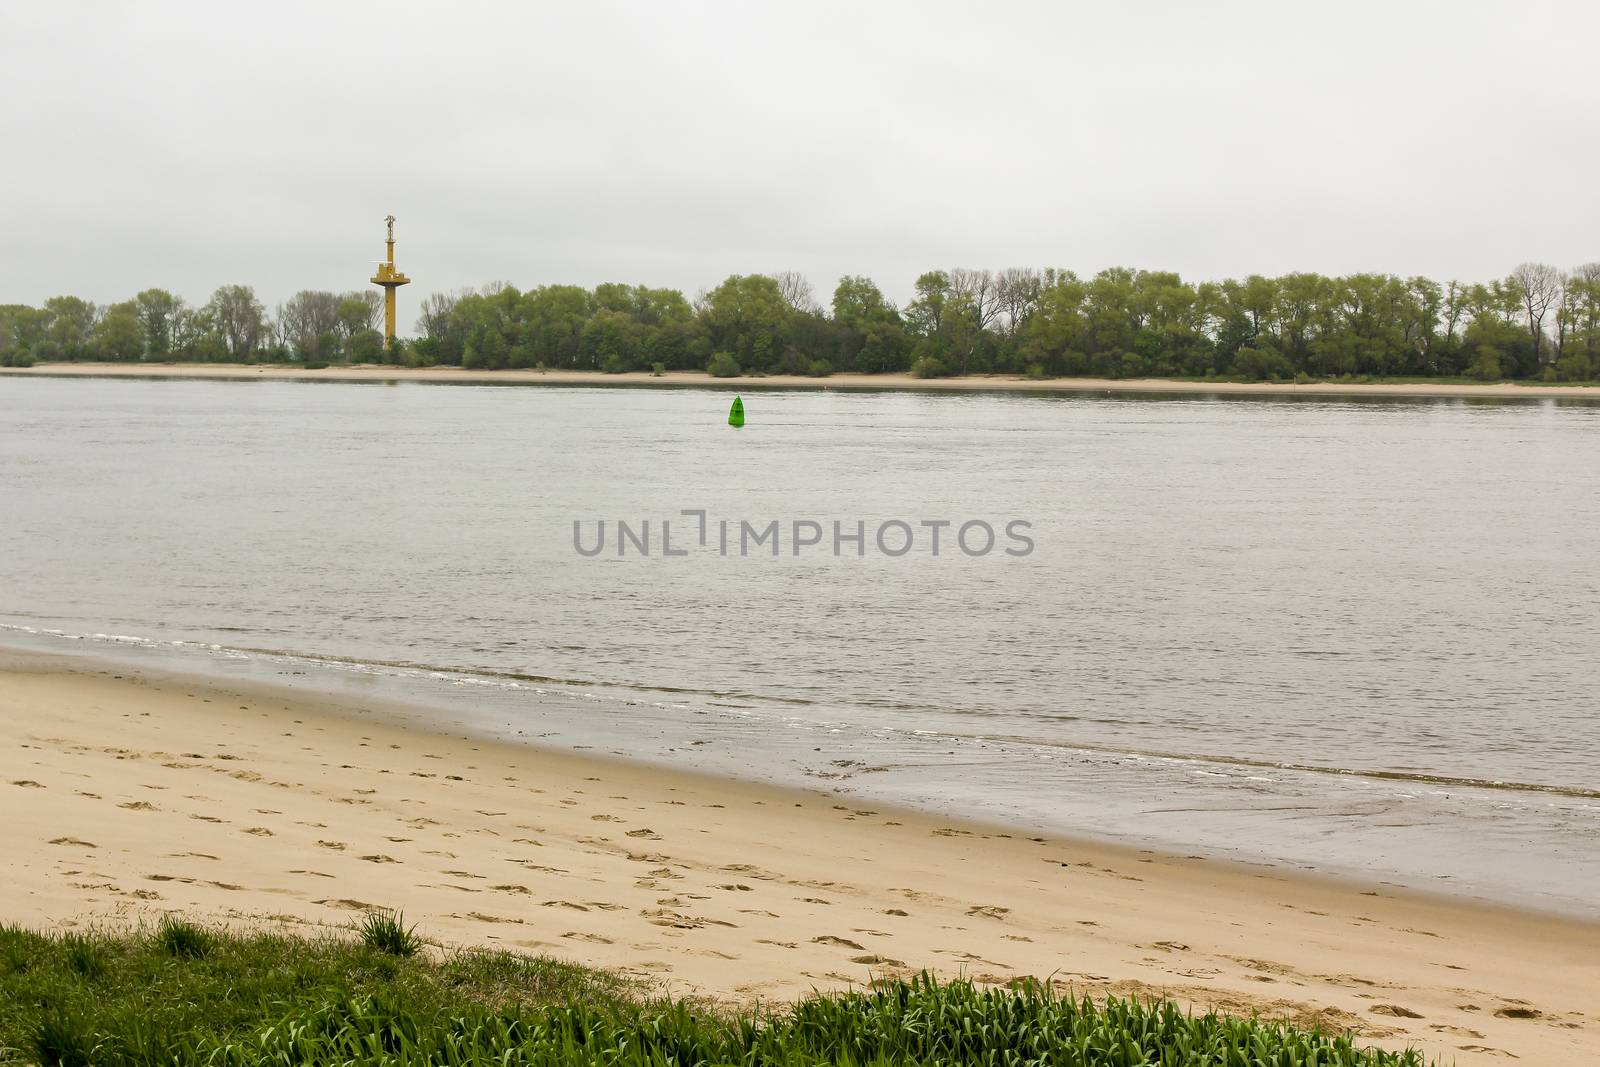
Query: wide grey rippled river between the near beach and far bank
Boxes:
[{"xmin": 0, "ymin": 379, "xmax": 1600, "ymax": 915}]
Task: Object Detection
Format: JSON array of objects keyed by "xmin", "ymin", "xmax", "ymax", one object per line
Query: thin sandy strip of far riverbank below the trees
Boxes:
[{"xmin": 0, "ymin": 363, "xmax": 1600, "ymax": 402}]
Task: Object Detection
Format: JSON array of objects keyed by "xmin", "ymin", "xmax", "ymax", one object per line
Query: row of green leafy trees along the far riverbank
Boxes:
[{"xmin": 0, "ymin": 262, "xmax": 1600, "ymax": 381}]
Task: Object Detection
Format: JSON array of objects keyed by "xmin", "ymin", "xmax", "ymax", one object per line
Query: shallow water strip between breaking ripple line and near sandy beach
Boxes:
[{"xmin": 0, "ymin": 622, "xmax": 1600, "ymax": 923}]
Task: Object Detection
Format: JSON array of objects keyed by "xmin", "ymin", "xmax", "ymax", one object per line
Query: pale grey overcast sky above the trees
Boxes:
[{"xmin": 0, "ymin": 0, "xmax": 1600, "ymax": 323}]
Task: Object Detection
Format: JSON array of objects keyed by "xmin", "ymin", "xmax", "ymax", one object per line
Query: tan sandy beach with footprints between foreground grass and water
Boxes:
[{"xmin": 0, "ymin": 659, "xmax": 1600, "ymax": 1064}]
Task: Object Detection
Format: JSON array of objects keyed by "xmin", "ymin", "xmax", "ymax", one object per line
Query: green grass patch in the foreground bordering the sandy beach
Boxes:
[{"xmin": 0, "ymin": 915, "xmax": 1424, "ymax": 1067}]
